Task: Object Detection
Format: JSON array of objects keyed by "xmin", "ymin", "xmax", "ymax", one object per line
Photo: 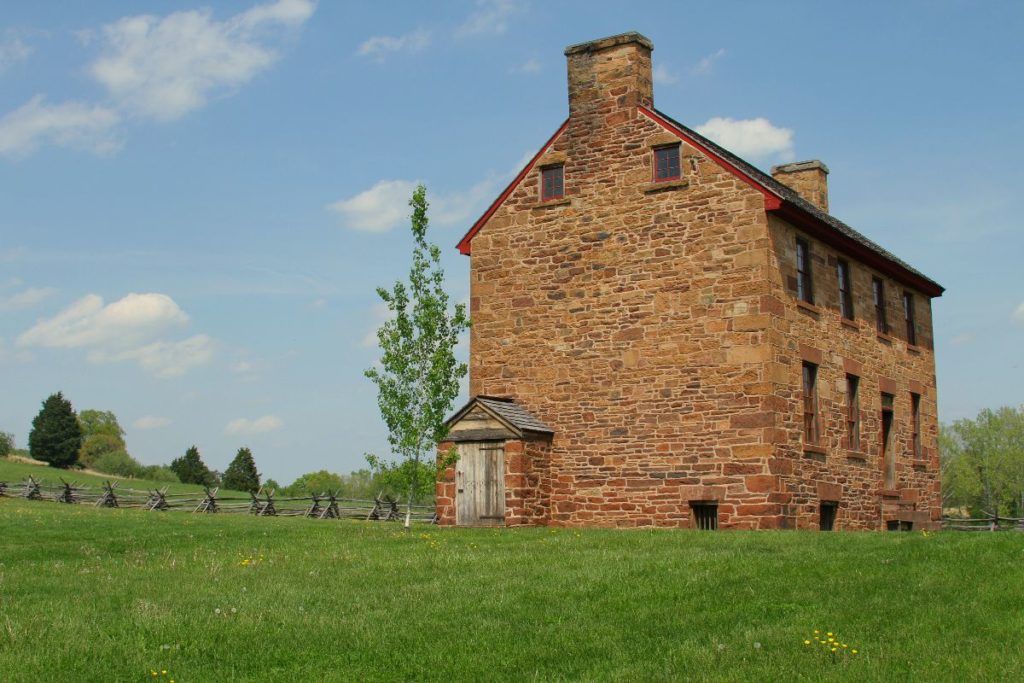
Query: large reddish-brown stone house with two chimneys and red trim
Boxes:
[{"xmin": 437, "ymin": 33, "xmax": 943, "ymax": 529}]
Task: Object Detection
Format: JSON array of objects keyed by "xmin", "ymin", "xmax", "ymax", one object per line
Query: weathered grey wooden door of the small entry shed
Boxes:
[{"xmin": 455, "ymin": 441, "xmax": 505, "ymax": 526}]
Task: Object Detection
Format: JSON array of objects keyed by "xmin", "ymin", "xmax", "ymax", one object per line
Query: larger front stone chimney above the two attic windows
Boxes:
[{"xmin": 565, "ymin": 33, "xmax": 654, "ymax": 129}]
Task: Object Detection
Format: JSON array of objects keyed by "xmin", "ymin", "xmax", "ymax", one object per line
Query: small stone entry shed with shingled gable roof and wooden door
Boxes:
[{"xmin": 437, "ymin": 396, "xmax": 554, "ymax": 526}]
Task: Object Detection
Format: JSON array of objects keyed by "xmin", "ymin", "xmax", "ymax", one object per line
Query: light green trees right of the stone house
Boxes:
[{"xmin": 939, "ymin": 407, "xmax": 1024, "ymax": 517}]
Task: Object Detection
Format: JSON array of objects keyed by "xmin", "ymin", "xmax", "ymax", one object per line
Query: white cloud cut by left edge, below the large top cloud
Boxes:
[{"xmin": 0, "ymin": 95, "xmax": 121, "ymax": 158}]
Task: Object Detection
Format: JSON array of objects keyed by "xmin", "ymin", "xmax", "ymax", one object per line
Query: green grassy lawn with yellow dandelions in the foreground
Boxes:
[{"xmin": 0, "ymin": 499, "xmax": 1024, "ymax": 681}]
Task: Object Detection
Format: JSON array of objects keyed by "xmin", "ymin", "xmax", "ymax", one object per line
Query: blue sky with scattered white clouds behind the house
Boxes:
[{"xmin": 0, "ymin": 0, "xmax": 1024, "ymax": 481}]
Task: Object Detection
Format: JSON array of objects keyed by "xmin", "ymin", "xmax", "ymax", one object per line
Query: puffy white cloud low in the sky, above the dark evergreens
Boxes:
[{"xmin": 17, "ymin": 293, "xmax": 215, "ymax": 378}]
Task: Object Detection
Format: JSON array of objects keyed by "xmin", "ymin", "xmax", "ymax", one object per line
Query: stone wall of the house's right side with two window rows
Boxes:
[{"xmin": 770, "ymin": 218, "xmax": 941, "ymax": 529}]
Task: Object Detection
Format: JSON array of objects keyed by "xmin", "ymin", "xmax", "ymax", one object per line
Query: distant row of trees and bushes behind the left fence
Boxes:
[{"xmin": 0, "ymin": 391, "xmax": 436, "ymax": 503}]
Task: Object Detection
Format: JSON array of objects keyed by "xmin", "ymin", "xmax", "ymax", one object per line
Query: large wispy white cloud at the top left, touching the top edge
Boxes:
[{"xmin": 89, "ymin": 0, "xmax": 315, "ymax": 121}]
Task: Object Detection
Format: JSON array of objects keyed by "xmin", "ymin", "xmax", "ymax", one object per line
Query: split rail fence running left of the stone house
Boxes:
[{"xmin": 0, "ymin": 476, "xmax": 437, "ymax": 523}]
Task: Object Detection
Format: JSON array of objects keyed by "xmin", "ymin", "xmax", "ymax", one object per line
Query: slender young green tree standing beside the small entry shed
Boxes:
[{"xmin": 366, "ymin": 185, "xmax": 469, "ymax": 529}]
